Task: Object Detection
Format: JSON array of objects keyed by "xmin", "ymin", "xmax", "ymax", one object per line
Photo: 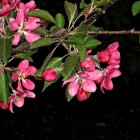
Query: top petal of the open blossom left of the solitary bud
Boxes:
[{"xmin": 17, "ymin": 60, "xmax": 29, "ymax": 72}]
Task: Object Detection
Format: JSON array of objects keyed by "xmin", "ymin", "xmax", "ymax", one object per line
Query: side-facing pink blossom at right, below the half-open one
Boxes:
[{"xmin": 96, "ymin": 65, "xmax": 121, "ymax": 93}]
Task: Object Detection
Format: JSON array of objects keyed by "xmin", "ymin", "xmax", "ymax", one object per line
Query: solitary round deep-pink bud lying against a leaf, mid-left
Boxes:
[{"xmin": 42, "ymin": 68, "xmax": 57, "ymax": 82}]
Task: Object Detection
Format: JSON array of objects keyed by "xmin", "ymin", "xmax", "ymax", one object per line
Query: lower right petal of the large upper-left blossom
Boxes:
[{"xmin": 24, "ymin": 31, "xmax": 41, "ymax": 43}]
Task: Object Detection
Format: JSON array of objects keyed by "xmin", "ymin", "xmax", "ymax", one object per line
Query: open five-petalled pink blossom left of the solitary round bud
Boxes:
[{"xmin": 12, "ymin": 60, "xmax": 37, "ymax": 92}]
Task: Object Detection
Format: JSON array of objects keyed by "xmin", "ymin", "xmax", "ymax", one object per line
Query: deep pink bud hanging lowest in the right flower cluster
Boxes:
[{"xmin": 77, "ymin": 89, "xmax": 88, "ymax": 101}]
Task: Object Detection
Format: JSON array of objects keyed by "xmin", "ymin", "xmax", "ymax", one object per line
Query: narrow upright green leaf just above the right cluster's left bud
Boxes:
[{"xmin": 76, "ymin": 45, "xmax": 86, "ymax": 62}]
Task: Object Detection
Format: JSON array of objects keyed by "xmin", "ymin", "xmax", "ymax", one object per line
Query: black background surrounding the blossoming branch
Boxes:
[{"xmin": 0, "ymin": 0, "xmax": 140, "ymax": 140}]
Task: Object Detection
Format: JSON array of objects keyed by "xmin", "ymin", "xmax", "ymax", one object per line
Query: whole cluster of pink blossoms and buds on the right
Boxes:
[{"xmin": 63, "ymin": 42, "xmax": 121, "ymax": 101}]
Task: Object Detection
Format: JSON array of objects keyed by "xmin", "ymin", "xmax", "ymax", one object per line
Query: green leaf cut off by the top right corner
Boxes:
[{"xmin": 132, "ymin": 1, "xmax": 140, "ymax": 16}]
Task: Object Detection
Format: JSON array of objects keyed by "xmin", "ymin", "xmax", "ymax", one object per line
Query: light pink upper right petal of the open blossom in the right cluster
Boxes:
[{"xmin": 85, "ymin": 70, "xmax": 102, "ymax": 80}]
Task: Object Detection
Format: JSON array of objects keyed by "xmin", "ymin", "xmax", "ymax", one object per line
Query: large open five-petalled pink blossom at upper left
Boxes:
[{"xmin": 10, "ymin": 3, "xmax": 40, "ymax": 45}]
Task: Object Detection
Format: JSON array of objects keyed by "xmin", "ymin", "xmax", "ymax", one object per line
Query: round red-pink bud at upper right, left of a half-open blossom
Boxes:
[{"xmin": 98, "ymin": 50, "xmax": 110, "ymax": 62}]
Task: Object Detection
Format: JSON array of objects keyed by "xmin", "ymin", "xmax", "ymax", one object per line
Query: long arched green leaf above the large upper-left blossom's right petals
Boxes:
[{"xmin": 28, "ymin": 10, "xmax": 55, "ymax": 23}]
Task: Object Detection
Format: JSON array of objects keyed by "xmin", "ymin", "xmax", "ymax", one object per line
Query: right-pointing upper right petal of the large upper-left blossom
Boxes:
[{"xmin": 25, "ymin": 17, "xmax": 41, "ymax": 30}]
